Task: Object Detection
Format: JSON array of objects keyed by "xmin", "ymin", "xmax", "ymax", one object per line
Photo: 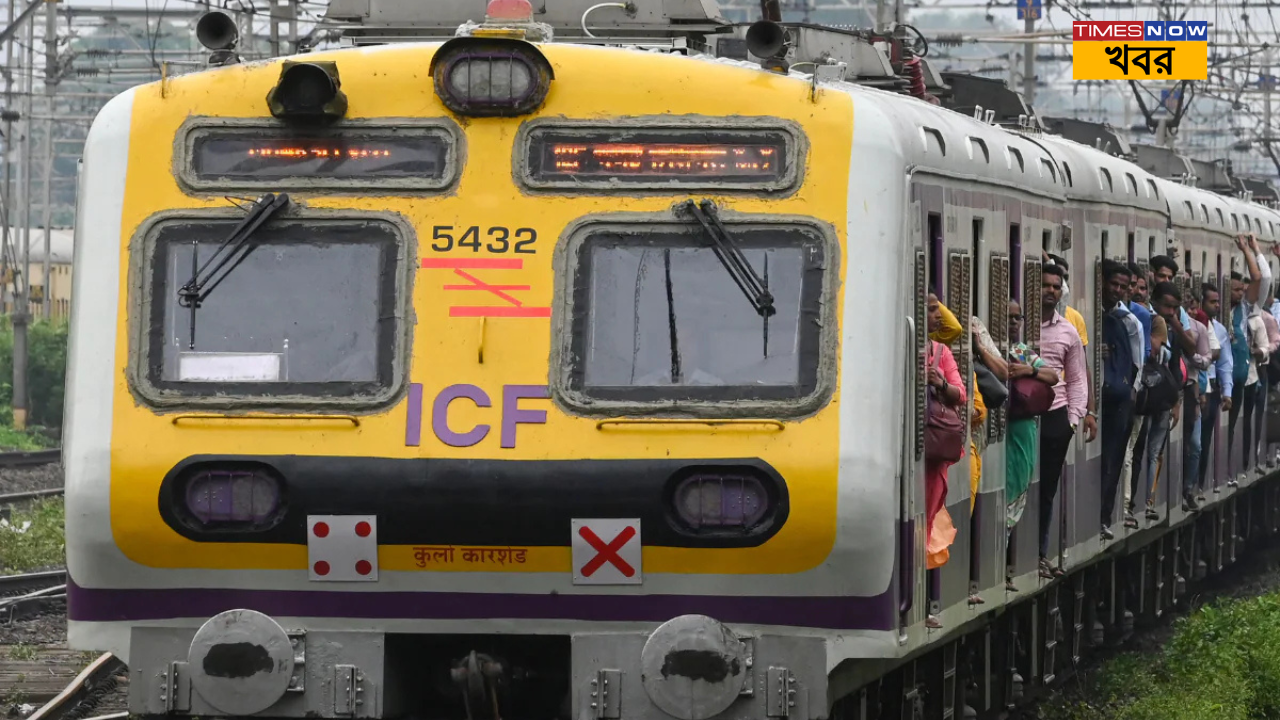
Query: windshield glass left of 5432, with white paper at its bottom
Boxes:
[{"xmin": 138, "ymin": 212, "xmax": 403, "ymax": 402}]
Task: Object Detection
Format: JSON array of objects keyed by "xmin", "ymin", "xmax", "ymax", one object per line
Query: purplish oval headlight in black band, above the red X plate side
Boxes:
[{"xmin": 671, "ymin": 468, "xmax": 774, "ymax": 532}]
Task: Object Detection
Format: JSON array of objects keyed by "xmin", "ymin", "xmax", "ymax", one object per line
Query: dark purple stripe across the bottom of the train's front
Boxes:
[{"xmin": 67, "ymin": 578, "xmax": 897, "ymax": 630}]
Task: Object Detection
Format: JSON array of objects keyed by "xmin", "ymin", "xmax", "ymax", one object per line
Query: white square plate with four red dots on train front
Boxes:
[{"xmin": 307, "ymin": 515, "xmax": 378, "ymax": 582}]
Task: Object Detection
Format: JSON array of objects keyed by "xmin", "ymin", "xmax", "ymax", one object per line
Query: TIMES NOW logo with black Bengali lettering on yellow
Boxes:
[{"xmin": 1071, "ymin": 20, "xmax": 1208, "ymax": 79}]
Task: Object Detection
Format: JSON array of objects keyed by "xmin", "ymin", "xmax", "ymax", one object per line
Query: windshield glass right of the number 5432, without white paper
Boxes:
[{"xmin": 570, "ymin": 228, "xmax": 823, "ymax": 402}]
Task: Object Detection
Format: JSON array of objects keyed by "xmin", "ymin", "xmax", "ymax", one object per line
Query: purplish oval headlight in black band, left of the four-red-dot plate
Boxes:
[{"xmin": 179, "ymin": 465, "xmax": 284, "ymax": 532}]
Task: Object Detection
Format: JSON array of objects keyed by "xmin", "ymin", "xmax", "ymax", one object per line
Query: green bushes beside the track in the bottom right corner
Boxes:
[{"xmin": 1044, "ymin": 593, "xmax": 1280, "ymax": 720}]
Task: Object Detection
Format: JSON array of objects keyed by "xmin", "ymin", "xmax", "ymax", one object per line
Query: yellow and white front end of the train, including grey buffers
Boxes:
[{"xmin": 65, "ymin": 2, "xmax": 905, "ymax": 720}]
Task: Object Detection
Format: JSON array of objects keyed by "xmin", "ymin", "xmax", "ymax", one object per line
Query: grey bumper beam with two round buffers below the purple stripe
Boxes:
[{"xmin": 129, "ymin": 607, "xmax": 827, "ymax": 720}]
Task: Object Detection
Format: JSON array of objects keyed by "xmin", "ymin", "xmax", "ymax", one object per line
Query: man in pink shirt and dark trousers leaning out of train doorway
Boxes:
[{"xmin": 1039, "ymin": 265, "xmax": 1098, "ymax": 578}]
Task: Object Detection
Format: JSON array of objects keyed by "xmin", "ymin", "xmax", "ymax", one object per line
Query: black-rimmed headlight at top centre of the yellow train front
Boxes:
[{"xmin": 431, "ymin": 37, "xmax": 554, "ymax": 118}]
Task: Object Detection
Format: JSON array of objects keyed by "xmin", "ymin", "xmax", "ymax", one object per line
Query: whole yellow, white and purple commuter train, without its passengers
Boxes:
[{"xmin": 64, "ymin": 0, "xmax": 1280, "ymax": 720}]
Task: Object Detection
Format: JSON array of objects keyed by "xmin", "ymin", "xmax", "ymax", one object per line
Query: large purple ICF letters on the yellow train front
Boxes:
[{"xmin": 404, "ymin": 383, "xmax": 550, "ymax": 448}]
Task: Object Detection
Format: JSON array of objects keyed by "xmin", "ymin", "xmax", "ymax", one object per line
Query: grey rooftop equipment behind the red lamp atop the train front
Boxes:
[{"xmin": 325, "ymin": 0, "xmax": 731, "ymax": 49}]
